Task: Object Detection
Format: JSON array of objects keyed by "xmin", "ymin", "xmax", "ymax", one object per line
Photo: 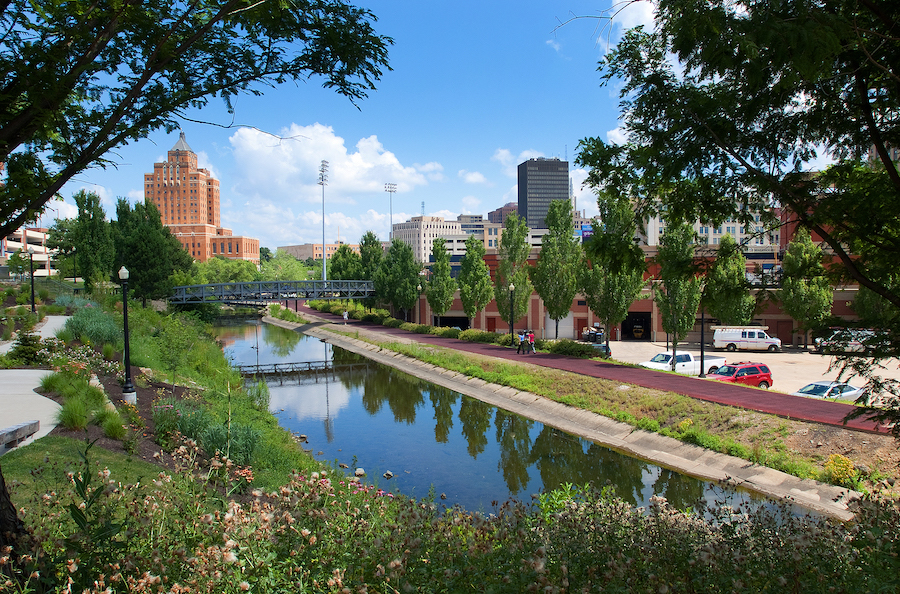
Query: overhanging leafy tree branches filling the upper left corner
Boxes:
[{"xmin": 0, "ymin": 0, "xmax": 392, "ymax": 235}]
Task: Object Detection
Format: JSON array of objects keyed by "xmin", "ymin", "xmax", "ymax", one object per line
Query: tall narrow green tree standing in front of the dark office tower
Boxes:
[{"xmin": 531, "ymin": 200, "xmax": 582, "ymax": 338}]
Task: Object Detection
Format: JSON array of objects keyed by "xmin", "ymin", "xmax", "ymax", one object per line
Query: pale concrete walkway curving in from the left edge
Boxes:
[{"xmin": 0, "ymin": 316, "xmax": 68, "ymax": 445}]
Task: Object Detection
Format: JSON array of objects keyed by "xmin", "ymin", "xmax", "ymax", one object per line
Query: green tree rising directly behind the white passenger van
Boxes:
[{"xmin": 703, "ymin": 234, "xmax": 756, "ymax": 326}]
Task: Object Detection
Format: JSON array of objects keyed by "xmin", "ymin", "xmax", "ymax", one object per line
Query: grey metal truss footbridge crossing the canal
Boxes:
[{"xmin": 169, "ymin": 280, "xmax": 375, "ymax": 305}]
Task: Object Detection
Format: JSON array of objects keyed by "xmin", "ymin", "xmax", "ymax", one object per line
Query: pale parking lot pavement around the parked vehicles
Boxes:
[{"xmin": 609, "ymin": 340, "xmax": 900, "ymax": 394}]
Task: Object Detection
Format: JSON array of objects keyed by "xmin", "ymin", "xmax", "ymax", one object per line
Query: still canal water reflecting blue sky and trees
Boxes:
[{"xmin": 216, "ymin": 324, "xmax": 763, "ymax": 513}]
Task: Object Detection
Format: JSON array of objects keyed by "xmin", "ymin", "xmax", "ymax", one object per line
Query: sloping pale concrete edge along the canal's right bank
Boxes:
[{"xmin": 263, "ymin": 312, "xmax": 859, "ymax": 521}]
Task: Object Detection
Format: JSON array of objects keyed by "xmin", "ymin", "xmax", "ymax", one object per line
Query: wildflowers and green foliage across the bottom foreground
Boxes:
[{"xmin": 0, "ymin": 442, "xmax": 900, "ymax": 593}]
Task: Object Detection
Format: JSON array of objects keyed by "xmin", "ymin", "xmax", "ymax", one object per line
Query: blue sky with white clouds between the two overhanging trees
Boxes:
[{"xmin": 42, "ymin": 0, "xmax": 652, "ymax": 250}]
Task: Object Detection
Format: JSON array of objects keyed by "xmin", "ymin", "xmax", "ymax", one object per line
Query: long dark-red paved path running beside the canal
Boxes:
[{"xmin": 298, "ymin": 303, "xmax": 887, "ymax": 433}]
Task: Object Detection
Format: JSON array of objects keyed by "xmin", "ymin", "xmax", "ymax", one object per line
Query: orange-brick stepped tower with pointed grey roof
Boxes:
[{"xmin": 144, "ymin": 132, "xmax": 259, "ymax": 265}]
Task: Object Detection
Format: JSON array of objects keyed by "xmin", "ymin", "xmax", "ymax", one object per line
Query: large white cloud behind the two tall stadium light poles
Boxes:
[{"xmin": 222, "ymin": 123, "xmax": 443, "ymax": 248}]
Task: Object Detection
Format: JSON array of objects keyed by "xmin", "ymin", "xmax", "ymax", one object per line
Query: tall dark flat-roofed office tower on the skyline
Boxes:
[{"xmin": 518, "ymin": 158, "xmax": 571, "ymax": 229}]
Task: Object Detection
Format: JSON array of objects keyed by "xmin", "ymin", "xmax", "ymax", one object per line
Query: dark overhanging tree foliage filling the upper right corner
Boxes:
[{"xmin": 578, "ymin": 0, "xmax": 900, "ymax": 420}]
